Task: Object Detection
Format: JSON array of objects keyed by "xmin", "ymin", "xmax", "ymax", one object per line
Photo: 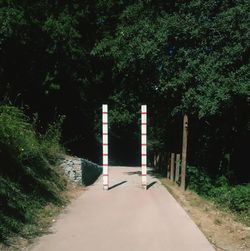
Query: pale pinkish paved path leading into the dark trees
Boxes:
[{"xmin": 31, "ymin": 167, "xmax": 214, "ymax": 251}]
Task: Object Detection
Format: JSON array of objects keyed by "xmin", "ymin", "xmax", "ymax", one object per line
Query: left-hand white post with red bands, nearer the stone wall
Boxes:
[{"xmin": 102, "ymin": 105, "xmax": 109, "ymax": 190}]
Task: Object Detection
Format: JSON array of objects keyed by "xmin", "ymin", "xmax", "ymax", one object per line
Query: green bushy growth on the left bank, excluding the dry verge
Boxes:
[{"xmin": 0, "ymin": 105, "xmax": 66, "ymax": 240}]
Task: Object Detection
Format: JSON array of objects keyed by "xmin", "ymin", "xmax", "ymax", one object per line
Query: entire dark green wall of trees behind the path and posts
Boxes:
[{"xmin": 0, "ymin": 0, "xmax": 250, "ymax": 226}]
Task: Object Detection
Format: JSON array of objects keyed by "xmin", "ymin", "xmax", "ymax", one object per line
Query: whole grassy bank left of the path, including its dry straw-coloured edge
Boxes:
[{"xmin": 0, "ymin": 105, "xmax": 100, "ymax": 248}]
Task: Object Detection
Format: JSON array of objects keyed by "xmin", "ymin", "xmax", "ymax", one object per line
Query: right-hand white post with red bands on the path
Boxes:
[{"xmin": 141, "ymin": 105, "xmax": 147, "ymax": 189}]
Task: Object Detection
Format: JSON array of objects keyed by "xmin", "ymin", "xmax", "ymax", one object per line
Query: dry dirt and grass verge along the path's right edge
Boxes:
[{"xmin": 161, "ymin": 179, "xmax": 250, "ymax": 251}]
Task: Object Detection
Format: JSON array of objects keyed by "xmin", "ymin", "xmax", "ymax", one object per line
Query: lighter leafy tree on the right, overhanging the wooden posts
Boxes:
[{"xmin": 92, "ymin": 0, "xmax": 250, "ymax": 182}]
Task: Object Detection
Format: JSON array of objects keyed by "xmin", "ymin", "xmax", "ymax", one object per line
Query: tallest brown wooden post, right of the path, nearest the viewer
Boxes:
[{"xmin": 181, "ymin": 114, "xmax": 188, "ymax": 190}]
